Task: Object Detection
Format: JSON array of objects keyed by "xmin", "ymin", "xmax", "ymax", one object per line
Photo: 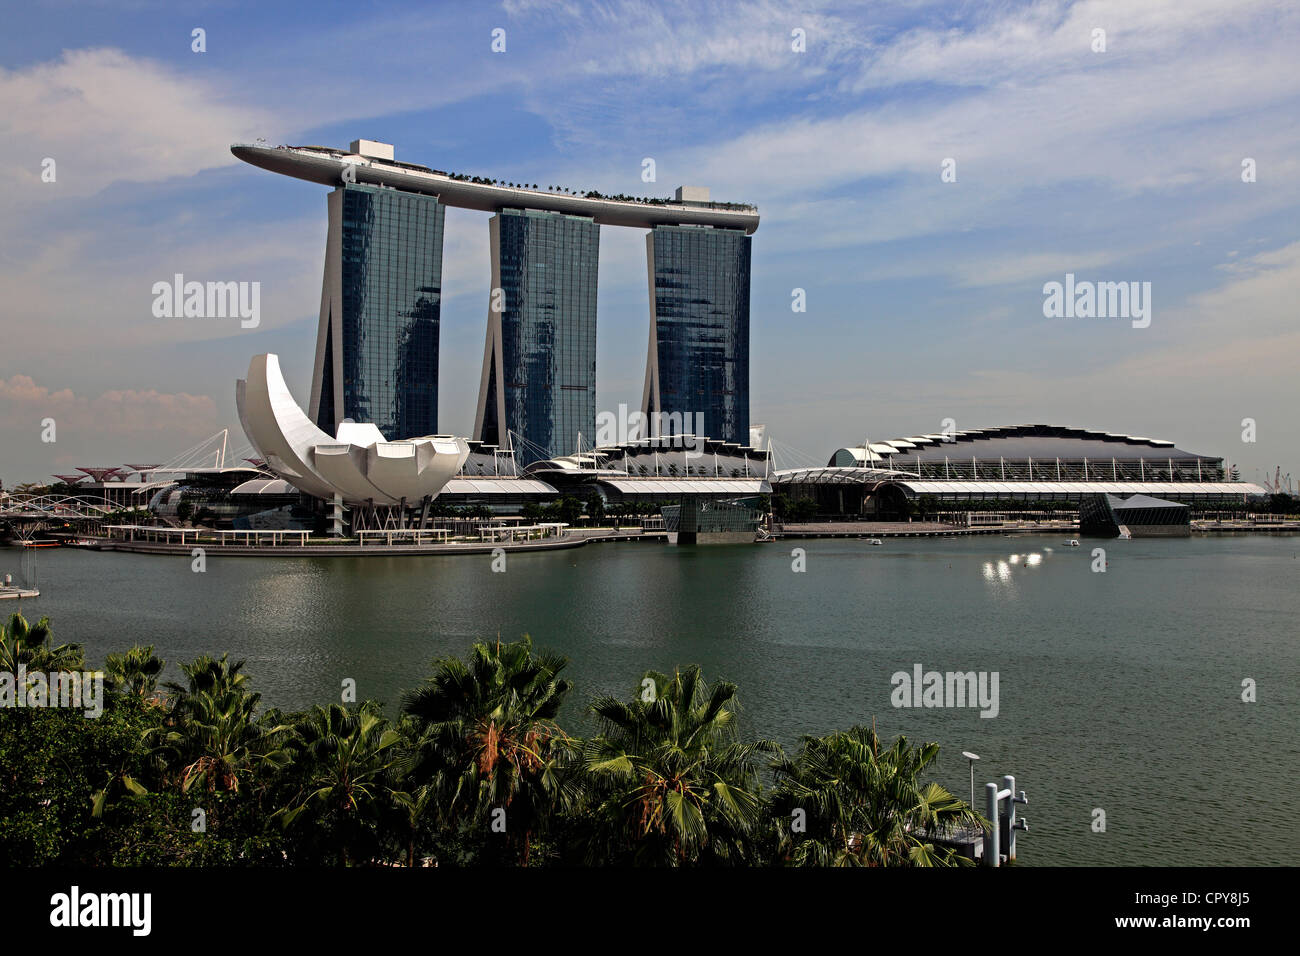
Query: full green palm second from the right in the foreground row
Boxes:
[{"xmin": 586, "ymin": 666, "xmax": 780, "ymax": 865}]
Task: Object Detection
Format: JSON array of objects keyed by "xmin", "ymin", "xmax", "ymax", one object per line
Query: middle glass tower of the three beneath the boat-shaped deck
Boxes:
[{"xmin": 475, "ymin": 209, "xmax": 601, "ymax": 464}]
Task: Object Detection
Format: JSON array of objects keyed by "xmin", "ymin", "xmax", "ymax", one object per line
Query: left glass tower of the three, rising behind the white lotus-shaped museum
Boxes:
[{"xmin": 311, "ymin": 183, "xmax": 445, "ymax": 441}]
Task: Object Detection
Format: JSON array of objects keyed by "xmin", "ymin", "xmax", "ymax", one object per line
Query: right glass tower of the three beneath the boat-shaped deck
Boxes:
[{"xmin": 642, "ymin": 225, "xmax": 753, "ymax": 445}]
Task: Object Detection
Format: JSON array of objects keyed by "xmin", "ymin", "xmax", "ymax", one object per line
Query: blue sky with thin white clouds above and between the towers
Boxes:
[{"xmin": 0, "ymin": 0, "xmax": 1300, "ymax": 485}]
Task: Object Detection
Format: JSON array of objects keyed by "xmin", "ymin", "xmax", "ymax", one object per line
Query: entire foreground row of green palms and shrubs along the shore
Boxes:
[{"xmin": 0, "ymin": 615, "xmax": 978, "ymax": 866}]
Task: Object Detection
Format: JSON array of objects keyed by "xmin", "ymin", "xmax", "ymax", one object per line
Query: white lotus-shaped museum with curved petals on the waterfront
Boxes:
[{"xmin": 235, "ymin": 354, "xmax": 469, "ymax": 506}]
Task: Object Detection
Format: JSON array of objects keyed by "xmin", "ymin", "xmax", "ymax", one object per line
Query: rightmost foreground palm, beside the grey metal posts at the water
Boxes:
[{"xmin": 772, "ymin": 727, "xmax": 979, "ymax": 866}]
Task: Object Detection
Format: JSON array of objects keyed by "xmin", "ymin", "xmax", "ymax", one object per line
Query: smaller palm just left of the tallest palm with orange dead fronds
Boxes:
[{"xmin": 274, "ymin": 701, "xmax": 400, "ymax": 865}]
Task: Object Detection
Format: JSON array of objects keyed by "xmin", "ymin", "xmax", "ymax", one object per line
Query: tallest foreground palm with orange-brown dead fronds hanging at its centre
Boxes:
[{"xmin": 403, "ymin": 635, "xmax": 579, "ymax": 865}]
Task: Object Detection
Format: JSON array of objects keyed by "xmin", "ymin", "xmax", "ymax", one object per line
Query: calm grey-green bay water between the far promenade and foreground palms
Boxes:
[{"xmin": 0, "ymin": 535, "xmax": 1300, "ymax": 865}]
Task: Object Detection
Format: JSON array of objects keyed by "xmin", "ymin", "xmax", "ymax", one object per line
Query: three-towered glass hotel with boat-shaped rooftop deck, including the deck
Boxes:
[{"xmin": 230, "ymin": 139, "xmax": 759, "ymax": 460}]
